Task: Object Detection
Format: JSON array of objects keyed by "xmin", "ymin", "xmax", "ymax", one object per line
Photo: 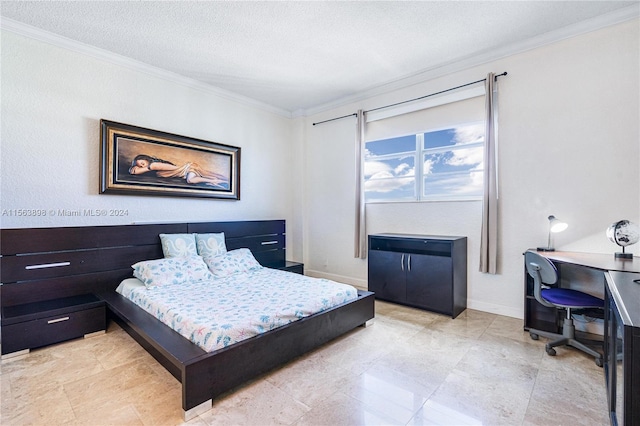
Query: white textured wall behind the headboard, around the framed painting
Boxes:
[{"xmin": 0, "ymin": 31, "xmax": 301, "ymax": 259}]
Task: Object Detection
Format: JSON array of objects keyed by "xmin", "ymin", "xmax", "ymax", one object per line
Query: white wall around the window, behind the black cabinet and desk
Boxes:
[{"xmin": 304, "ymin": 20, "xmax": 640, "ymax": 318}]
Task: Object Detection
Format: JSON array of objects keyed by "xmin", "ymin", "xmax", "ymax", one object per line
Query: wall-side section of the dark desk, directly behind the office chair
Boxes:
[{"xmin": 524, "ymin": 249, "xmax": 640, "ymax": 333}]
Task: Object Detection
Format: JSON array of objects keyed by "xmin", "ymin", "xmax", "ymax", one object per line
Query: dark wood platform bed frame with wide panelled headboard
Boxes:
[{"xmin": 0, "ymin": 220, "xmax": 374, "ymax": 420}]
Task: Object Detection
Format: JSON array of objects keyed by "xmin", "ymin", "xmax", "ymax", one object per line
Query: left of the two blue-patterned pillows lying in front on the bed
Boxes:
[{"xmin": 131, "ymin": 256, "xmax": 213, "ymax": 287}]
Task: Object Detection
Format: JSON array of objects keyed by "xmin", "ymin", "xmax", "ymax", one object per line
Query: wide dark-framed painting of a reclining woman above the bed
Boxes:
[{"xmin": 100, "ymin": 120, "xmax": 240, "ymax": 200}]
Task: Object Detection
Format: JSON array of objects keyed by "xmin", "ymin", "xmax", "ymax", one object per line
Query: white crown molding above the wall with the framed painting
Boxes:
[{"xmin": 0, "ymin": 17, "xmax": 291, "ymax": 118}]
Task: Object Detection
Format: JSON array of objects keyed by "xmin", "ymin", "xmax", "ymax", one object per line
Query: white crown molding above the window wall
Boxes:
[{"xmin": 302, "ymin": 3, "xmax": 640, "ymax": 117}]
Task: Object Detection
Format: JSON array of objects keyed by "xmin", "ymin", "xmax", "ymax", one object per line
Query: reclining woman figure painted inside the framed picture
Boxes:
[{"xmin": 129, "ymin": 154, "xmax": 229, "ymax": 189}]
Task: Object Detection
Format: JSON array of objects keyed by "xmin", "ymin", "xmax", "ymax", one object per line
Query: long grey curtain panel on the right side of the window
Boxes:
[{"xmin": 480, "ymin": 73, "xmax": 498, "ymax": 274}]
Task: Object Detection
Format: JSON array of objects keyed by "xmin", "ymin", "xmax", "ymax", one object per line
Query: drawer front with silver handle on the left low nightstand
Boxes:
[{"xmin": 2, "ymin": 305, "xmax": 107, "ymax": 354}]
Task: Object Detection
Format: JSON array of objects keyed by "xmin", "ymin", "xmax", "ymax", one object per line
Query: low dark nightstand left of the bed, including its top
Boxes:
[{"xmin": 2, "ymin": 294, "xmax": 107, "ymax": 356}]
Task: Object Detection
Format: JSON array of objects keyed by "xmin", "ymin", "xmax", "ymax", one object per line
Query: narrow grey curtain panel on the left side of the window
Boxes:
[{"xmin": 354, "ymin": 109, "xmax": 367, "ymax": 259}]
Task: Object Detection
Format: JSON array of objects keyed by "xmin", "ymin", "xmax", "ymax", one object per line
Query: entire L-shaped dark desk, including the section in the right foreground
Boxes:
[{"xmin": 524, "ymin": 251, "xmax": 640, "ymax": 426}]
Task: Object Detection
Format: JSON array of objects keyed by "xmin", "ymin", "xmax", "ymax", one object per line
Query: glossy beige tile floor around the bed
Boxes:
[{"xmin": 0, "ymin": 302, "xmax": 609, "ymax": 426}]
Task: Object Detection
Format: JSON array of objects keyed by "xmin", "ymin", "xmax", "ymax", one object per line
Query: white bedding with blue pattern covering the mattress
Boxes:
[{"xmin": 116, "ymin": 268, "xmax": 357, "ymax": 352}]
